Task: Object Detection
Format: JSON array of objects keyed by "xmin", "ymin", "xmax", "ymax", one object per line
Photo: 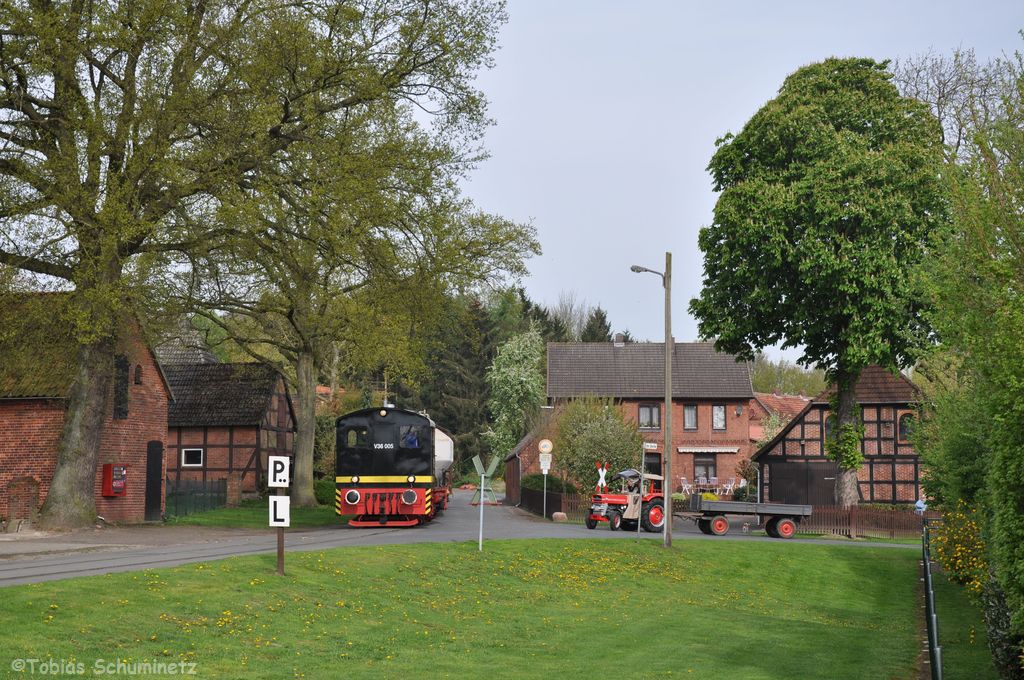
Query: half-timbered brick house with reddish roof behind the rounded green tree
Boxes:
[{"xmin": 754, "ymin": 366, "xmax": 922, "ymax": 505}]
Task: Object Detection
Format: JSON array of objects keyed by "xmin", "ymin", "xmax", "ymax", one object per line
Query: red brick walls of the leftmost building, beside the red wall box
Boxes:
[{"xmin": 0, "ymin": 329, "xmax": 168, "ymax": 522}]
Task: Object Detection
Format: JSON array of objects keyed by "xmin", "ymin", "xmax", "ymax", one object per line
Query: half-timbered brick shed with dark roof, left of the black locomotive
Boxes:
[{"xmin": 165, "ymin": 363, "xmax": 295, "ymax": 494}]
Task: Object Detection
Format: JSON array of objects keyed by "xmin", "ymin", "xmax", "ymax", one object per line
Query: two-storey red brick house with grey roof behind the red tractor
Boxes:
[{"xmin": 544, "ymin": 342, "xmax": 754, "ymax": 490}]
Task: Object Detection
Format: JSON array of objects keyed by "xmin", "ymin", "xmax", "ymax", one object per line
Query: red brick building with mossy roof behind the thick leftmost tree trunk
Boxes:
[{"xmin": 0, "ymin": 305, "xmax": 171, "ymax": 522}]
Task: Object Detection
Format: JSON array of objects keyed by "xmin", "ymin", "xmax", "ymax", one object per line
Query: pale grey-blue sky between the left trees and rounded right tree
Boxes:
[{"xmin": 465, "ymin": 0, "xmax": 1024, "ymax": 359}]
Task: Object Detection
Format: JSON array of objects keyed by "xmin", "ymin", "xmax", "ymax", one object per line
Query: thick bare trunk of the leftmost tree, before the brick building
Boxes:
[{"xmin": 40, "ymin": 337, "xmax": 115, "ymax": 528}]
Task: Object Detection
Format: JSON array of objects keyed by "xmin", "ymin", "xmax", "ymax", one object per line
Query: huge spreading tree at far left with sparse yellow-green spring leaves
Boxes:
[{"xmin": 0, "ymin": 0, "xmax": 504, "ymax": 526}]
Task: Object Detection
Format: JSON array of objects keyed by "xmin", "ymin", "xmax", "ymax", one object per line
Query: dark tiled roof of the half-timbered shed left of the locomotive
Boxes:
[{"xmin": 164, "ymin": 364, "xmax": 278, "ymax": 427}]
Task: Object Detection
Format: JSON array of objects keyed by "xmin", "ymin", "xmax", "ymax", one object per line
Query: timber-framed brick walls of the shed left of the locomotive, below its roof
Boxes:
[{"xmin": 167, "ymin": 379, "xmax": 295, "ymax": 494}]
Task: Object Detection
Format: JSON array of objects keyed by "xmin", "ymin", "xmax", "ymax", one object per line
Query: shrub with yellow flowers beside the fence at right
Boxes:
[{"xmin": 931, "ymin": 501, "xmax": 988, "ymax": 595}]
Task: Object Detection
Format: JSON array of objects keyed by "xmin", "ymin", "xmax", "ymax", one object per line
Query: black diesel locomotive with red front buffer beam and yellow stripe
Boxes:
[{"xmin": 335, "ymin": 406, "xmax": 455, "ymax": 526}]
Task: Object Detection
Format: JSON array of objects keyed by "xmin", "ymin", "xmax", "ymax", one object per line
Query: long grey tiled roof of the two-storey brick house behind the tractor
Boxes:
[{"xmin": 548, "ymin": 342, "xmax": 754, "ymax": 399}]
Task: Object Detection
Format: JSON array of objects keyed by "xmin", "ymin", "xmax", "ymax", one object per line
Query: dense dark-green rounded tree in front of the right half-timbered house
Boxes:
[{"xmin": 690, "ymin": 58, "xmax": 946, "ymax": 506}]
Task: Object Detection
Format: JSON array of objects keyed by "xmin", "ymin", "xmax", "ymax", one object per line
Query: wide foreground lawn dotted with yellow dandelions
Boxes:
[{"xmin": 0, "ymin": 539, "xmax": 920, "ymax": 680}]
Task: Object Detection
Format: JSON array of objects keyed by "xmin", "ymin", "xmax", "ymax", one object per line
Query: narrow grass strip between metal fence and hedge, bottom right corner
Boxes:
[{"xmin": 932, "ymin": 571, "xmax": 999, "ymax": 680}]
